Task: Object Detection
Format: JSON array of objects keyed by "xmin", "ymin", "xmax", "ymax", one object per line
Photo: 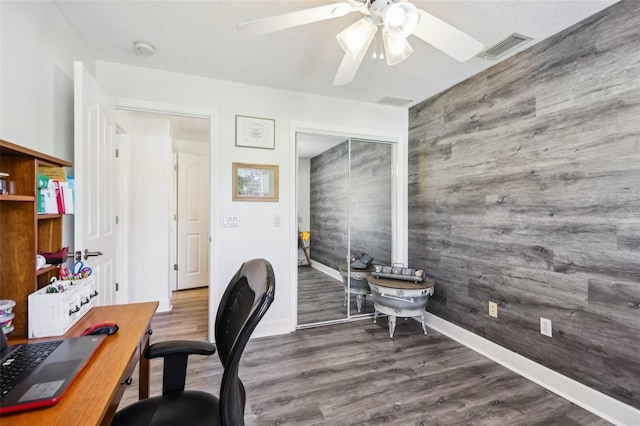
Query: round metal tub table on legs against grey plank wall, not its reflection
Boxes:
[{"xmin": 367, "ymin": 275, "xmax": 435, "ymax": 339}]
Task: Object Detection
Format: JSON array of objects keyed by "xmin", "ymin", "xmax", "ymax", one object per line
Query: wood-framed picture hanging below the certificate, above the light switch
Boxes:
[{"xmin": 232, "ymin": 163, "xmax": 279, "ymax": 201}]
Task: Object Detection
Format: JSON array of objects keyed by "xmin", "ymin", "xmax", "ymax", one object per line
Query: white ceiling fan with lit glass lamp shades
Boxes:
[{"xmin": 238, "ymin": 0, "xmax": 484, "ymax": 86}]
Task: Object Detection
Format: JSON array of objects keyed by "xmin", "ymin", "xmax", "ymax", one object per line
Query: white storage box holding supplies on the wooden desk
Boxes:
[{"xmin": 29, "ymin": 276, "xmax": 98, "ymax": 338}]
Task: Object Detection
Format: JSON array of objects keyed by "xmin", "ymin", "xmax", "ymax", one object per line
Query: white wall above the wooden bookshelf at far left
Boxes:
[{"xmin": 0, "ymin": 0, "xmax": 95, "ymax": 256}]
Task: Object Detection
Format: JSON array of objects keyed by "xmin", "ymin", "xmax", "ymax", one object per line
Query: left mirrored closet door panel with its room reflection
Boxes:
[{"xmin": 296, "ymin": 134, "xmax": 349, "ymax": 325}]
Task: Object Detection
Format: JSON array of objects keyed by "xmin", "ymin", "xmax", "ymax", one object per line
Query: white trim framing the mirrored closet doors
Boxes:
[{"xmin": 289, "ymin": 121, "xmax": 408, "ymax": 331}]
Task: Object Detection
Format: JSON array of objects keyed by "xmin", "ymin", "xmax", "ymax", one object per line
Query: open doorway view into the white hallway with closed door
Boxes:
[{"xmin": 119, "ymin": 109, "xmax": 211, "ymax": 310}]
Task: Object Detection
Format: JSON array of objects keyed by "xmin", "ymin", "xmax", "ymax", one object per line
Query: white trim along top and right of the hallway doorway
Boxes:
[{"xmin": 113, "ymin": 98, "xmax": 222, "ymax": 342}]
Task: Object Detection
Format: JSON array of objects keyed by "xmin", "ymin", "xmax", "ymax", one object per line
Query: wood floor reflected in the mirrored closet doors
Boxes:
[{"xmin": 298, "ymin": 266, "xmax": 373, "ymax": 325}]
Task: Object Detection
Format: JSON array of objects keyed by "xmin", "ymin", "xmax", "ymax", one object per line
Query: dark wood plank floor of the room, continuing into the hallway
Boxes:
[{"xmin": 121, "ymin": 289, "xmax": 608, "ymax": 426}]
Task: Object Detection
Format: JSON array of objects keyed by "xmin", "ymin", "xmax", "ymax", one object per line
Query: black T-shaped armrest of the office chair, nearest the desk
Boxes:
[{"xmin": 144, "ymin": 340, "xmax": 216, "ymax": 395}]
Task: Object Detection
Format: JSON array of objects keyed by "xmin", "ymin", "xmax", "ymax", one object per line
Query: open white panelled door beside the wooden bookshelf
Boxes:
[{"xmin": 73, "ymin": 62, "xmax": 116, "ymax": 305}]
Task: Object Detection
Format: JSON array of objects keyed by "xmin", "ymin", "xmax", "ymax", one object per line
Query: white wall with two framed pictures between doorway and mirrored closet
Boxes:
[{"xmin": 96, "ymin": 61, "xmax": 408, "ymax": 335}]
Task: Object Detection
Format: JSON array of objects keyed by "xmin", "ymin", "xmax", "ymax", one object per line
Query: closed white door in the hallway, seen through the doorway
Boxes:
[{"xmin": 178, "ymin": 153, "xmax": 209, "ymax": 290}]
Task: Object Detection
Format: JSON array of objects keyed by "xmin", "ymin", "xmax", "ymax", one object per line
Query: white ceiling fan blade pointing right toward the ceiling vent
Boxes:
[{"xmin": 413, "ymin": 9, "xmax": 484, "ymax": 62}]
